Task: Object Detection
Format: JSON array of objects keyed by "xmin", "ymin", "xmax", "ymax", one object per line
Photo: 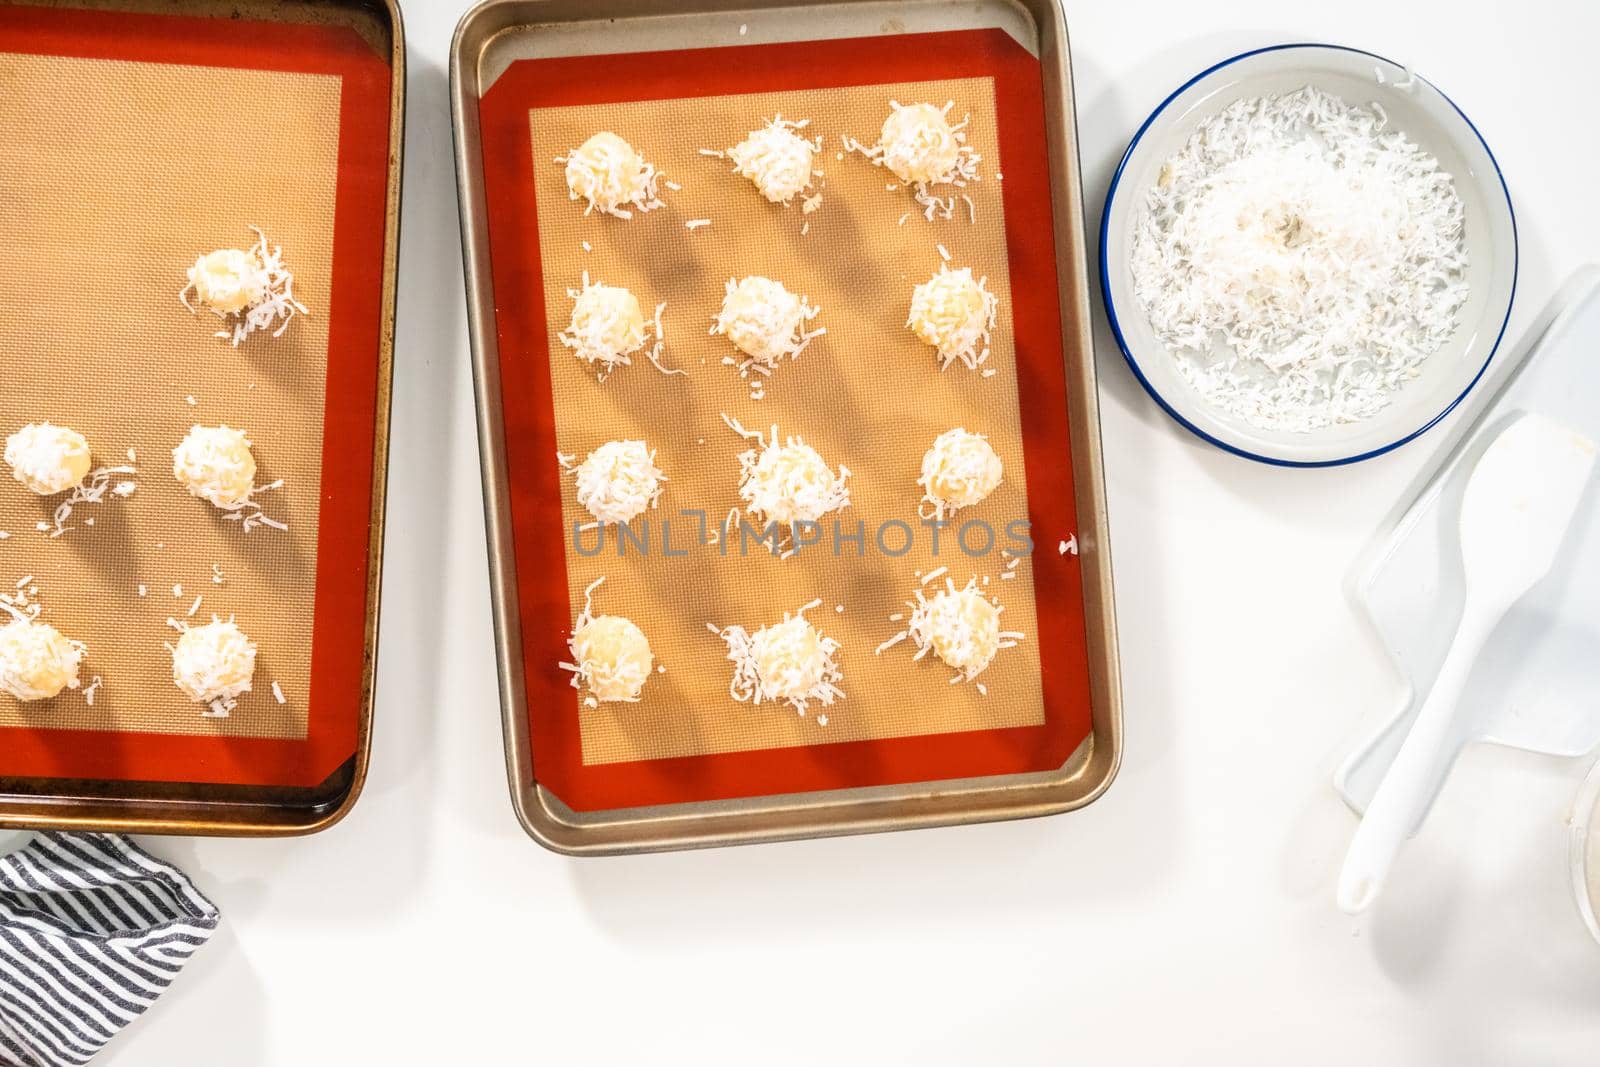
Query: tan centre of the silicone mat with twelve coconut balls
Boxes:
[{"xmin": 530, "ymin": 78, "xmax": 1043, "ymax": 765}]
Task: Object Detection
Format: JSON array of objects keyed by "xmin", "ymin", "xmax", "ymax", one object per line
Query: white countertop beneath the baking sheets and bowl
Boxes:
[{"xmin": 106, "ymin": 0, "xmax": 1600, "ymax": 1067}]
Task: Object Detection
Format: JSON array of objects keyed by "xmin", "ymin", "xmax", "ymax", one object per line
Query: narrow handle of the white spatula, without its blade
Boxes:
[{"xmin": 1339, "ymin": 598, "xmax": 1504, "ymax": 915}]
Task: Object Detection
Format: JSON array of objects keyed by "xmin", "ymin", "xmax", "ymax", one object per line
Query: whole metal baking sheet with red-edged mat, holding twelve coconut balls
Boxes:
[{"xmin": 451, "ymin": 3, "xmax": 1120, "ymax": 853}]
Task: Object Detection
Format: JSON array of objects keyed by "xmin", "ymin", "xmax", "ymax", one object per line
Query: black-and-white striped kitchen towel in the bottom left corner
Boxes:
[{"xmin": 0, "ymin": 833, "xmax": 219, "ymax": 1067}]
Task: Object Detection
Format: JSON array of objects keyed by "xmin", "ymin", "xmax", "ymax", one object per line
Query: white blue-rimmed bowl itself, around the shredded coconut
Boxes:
[{"xmin": 1099, "ymin": 45, "xmax": 1517, "ymax": 467}]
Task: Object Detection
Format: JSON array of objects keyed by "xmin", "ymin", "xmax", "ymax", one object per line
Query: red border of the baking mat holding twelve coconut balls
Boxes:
[{"xmin": 480, "ymin": 30, "xmax": 1091, "ymax": 811}]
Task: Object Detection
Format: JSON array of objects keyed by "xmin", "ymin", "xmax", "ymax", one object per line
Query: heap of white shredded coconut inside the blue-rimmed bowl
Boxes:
[{"xmin": 1131, "ymin": 86, "xmax": 1467, "ymax": 434}]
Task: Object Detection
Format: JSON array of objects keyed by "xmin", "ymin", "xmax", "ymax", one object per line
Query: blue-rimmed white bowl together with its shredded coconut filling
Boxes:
[{"xmin": 1101, "ymin": 45, "xmax": 1517, "ymax": 467}]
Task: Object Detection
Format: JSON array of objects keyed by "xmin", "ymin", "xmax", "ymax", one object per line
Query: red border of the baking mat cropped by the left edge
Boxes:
[{"xmin": 0, "ymin": 5, "xmax": 390, "ymax": 787}]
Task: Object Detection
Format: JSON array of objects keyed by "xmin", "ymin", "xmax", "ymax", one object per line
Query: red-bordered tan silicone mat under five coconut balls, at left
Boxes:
[{"xmin": 0, "ymin": 6, "xmax": 389, "ymax": 785}]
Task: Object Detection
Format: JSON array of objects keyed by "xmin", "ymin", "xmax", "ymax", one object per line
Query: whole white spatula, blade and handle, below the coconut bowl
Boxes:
[{"xmin": 1339, "ymin": 413, "xmax": 1595, "ymax": 913}]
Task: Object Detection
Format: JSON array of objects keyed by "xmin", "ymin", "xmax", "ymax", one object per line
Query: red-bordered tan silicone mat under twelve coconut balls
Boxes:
[{"xmin": 482, "ymin": 32, "xmax": 1090, "ymax": 809}]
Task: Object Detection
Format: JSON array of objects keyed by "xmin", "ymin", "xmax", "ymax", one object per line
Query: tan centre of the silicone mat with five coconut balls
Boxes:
[{"xmin": 0, "ymin": 54, "xmax": 339, "ymax": 739}]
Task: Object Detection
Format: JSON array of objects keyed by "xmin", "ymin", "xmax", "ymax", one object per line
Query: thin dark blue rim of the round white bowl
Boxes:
[{"xmin": 1099, "ymin": 42, "xmax": 1522, "ymax": 467}]
